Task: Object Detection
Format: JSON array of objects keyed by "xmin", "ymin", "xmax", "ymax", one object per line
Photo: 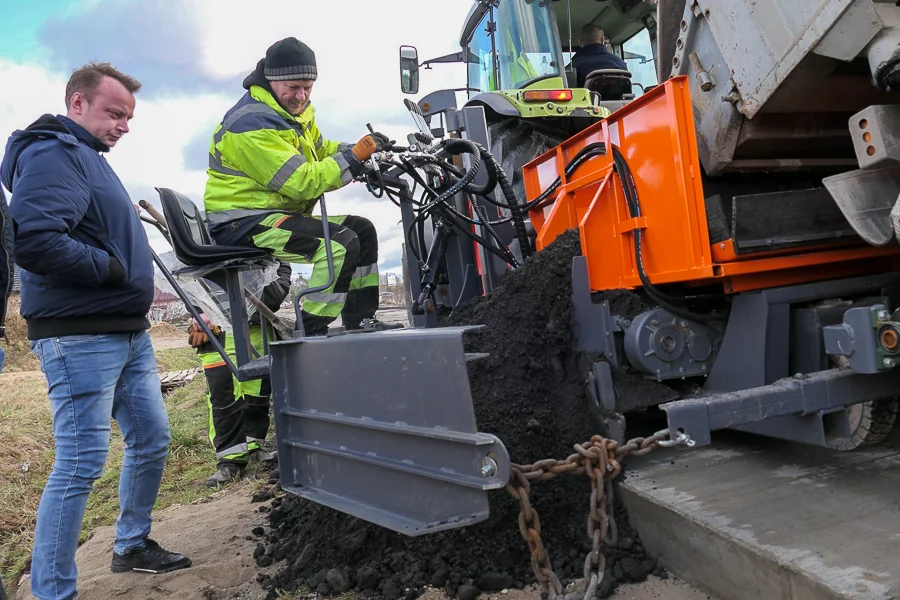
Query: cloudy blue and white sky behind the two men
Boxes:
[{"xmin": 0, "ymin": 0, "xmax": 471, "ymax": 271}]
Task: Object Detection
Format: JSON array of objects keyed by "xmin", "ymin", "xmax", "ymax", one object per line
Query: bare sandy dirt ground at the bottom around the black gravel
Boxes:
[{"xmin": 15, "ymin": 484, "xmax": 710, "ymax": 600}]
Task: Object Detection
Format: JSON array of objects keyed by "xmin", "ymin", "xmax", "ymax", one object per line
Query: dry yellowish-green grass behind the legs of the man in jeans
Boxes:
[{"xmin": 0, "ymin": 348, "xmax": 215, "ymax": 593}]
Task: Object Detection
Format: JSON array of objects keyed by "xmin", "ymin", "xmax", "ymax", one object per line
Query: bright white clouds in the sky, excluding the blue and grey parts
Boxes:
[{"xmin": 0, "ymin": 0, "xmax": 470, "ymax": 272}]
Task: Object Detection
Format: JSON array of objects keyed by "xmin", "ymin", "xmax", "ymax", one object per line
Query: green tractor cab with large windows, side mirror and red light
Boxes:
[{"xmin": 401, "ymin": 0, "xmax": 657, "ymax": 131}]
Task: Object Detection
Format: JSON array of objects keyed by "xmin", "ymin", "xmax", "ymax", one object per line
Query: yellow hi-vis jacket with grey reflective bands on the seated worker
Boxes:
[{"xmin": 203, "ymin": 85, "xmax": 353, "ymax": 225}]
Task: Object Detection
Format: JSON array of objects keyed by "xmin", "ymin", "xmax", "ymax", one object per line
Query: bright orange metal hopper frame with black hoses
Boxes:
[{"xmin": 523, "ymin": 76, "xmax": 900, "ymax": 293}]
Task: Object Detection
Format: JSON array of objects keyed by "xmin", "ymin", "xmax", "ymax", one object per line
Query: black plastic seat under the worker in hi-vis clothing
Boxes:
[{"xmin": 156, "ymin": 188, "xmax": 269, "ymax": 267}]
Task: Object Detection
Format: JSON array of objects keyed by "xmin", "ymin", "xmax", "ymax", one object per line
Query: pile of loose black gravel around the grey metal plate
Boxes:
[{"xmin": 255, "ymin": 231, "xmax": 668, "ymax": 600}]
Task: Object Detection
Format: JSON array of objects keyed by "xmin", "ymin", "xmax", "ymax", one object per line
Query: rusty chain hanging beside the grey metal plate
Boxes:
[{"xmin": 506, "ymin": 429, "xmax": 694, "ymax": 600}]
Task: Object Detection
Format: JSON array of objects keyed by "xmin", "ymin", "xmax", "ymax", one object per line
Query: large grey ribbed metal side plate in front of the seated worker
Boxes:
[{"xmin": 271, "ymin": 327, "xmax": 510, "ymax": 536}]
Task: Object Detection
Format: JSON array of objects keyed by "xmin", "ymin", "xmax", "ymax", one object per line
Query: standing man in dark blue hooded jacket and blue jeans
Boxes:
[{"xmin": 0, "ymin": 63, "xmax": 191, "ymax": 600}]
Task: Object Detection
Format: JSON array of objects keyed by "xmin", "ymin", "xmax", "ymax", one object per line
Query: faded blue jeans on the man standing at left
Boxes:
[{"xmin": 31, "ymin": 331, "xmax": 170, "ymax": 600}]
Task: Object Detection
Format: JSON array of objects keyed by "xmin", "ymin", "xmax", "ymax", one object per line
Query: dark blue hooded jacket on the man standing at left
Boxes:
[{"xmin": 0, "ymin": 115, "xmax": 155, "ymax": 340}]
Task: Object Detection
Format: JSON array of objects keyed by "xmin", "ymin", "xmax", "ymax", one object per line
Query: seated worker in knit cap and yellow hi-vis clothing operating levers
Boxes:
[{"xmin": 203, "ymin": 37, "xmax": 394, "ymax": 335}]
